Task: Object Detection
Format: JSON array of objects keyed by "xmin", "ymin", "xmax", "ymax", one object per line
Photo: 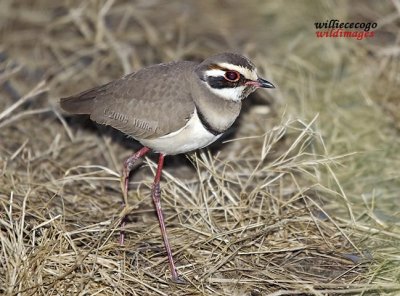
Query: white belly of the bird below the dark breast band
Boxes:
[{"xmin": 140, "ymin": 110, "xmax": 222, "ymax": 155}]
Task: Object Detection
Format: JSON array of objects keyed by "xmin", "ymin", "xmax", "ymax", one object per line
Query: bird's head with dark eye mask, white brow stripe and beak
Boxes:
[{"xmin": 195, "ymin": 53, "xmax": 274, "ymax": 102}]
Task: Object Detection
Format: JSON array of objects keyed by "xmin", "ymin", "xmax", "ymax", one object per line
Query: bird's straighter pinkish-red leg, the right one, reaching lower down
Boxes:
[{"xmin": 151, "ymin": 154, "xmax": 185, "ymax": 284}]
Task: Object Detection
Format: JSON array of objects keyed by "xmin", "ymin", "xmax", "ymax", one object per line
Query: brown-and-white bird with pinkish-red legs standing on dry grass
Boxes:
[{"xmin": 60, "ymin": 52, "xmax": 275, "ymax": 283}]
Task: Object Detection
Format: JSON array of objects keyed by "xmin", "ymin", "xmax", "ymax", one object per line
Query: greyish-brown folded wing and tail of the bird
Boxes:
[{"xmin": 60, "ymin": 62, "xmax": 196, "ymax": 140}]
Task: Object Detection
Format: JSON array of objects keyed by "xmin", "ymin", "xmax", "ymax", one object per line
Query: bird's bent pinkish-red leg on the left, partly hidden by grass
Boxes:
[{"xmin": 119, "ymin": 147, "xmax": 150, "ymax": 245}]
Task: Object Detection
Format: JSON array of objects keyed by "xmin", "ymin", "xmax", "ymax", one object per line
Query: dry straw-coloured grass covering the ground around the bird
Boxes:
[{"xmin": 0, "ymin": 0, "xmax": 400, "ymax": 296}]
